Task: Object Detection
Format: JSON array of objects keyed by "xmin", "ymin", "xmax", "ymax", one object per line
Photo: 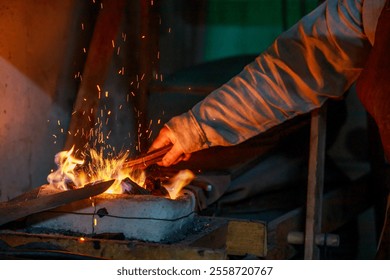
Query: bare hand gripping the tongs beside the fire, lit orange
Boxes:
[{"xmin": 149, "ymin": 126, "xmax": 191, "ymax": 166}]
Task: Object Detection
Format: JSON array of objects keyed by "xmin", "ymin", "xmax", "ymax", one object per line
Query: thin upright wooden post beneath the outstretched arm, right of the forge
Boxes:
[{"xmin": 304, "ymin": 105, "xmax": 326, "ymax": 260}]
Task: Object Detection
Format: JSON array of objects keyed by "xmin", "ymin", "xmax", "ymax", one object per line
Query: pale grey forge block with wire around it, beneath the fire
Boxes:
[{"xmin": 27, "ymin": 184, "xmax": 196, "ymax": 242}]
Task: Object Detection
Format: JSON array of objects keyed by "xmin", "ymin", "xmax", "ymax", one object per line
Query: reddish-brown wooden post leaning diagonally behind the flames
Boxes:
[{"xmin": 64, "ymin": 0, "xmax": 126, "ymax": 151}]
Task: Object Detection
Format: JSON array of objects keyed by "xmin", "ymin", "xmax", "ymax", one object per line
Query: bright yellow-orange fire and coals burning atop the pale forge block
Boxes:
[{"xmin": 47, "ymin": 147, "xmax": 194, "ymax": 199}]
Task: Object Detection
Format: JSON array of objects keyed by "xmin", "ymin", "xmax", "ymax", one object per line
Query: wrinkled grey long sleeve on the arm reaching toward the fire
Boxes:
[{"xmin": 152, "ymin": 0, "xmax": 371, "ymax": 166}]
